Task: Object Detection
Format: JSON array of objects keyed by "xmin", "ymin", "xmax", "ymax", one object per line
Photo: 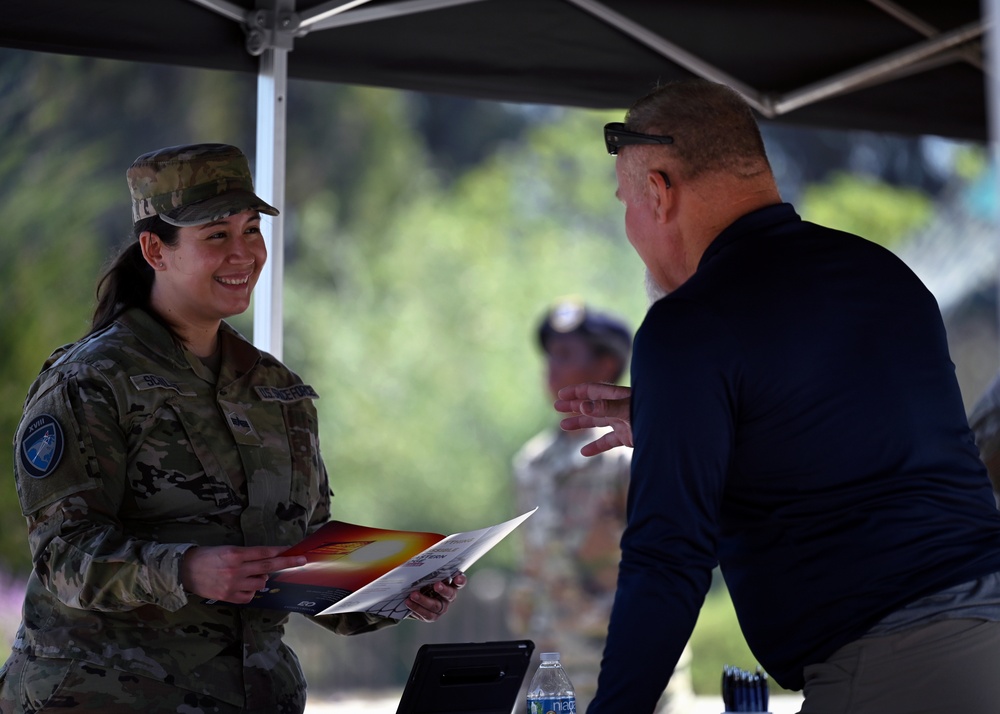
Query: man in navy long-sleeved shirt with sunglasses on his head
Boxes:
[{"xmin": 555, "ymin": 80, "xmax": 1000, "ymax": 714}]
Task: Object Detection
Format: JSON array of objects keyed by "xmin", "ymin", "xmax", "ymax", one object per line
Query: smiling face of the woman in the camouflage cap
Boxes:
[{"xmin": 140, "ymin": 210, "xmax": 267, "ymax": 331}]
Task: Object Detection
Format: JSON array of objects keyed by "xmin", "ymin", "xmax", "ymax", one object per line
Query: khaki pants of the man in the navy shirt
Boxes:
[{"xmin": 799, "ymin": 619, "xmax": 1000, "ymax": 714}]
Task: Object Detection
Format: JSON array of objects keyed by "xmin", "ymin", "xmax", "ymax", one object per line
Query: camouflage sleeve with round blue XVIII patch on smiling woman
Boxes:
[{"xmin": 14, "ymin": 367, "xmax": 191, "ymax": 612}]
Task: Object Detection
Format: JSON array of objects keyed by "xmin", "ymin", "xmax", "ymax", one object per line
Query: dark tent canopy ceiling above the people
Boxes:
[{"xmin": 0, "ymin": 0, "xmax": 988, "ymax": 140}]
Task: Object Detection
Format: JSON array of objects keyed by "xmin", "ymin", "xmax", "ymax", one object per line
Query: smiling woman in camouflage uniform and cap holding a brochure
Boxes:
[{"xmin": 0, "ymin": 144, "xmax": 465, "ymax": 714}]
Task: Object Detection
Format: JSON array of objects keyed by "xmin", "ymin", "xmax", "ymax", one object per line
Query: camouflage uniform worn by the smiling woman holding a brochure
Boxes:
[{"xmin": 0, "ymin": 310, "xmax": 391, "ymax": 714}]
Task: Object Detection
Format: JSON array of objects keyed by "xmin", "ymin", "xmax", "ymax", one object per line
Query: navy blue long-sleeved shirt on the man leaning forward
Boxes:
[{"xmin": 591, "ymin": 204, "xmax": 1000, "ymax": 711}]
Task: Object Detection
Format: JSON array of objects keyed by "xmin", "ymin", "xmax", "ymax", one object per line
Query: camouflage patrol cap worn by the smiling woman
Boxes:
[{"xmin": 126, "ymin": 144, "xmax": 278, "ymax": 227}]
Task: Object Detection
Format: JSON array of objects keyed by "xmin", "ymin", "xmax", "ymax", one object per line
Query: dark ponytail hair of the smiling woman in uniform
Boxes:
[{"xmin": 88, "ymin": 216, "xmax": 179, "ymax": 334}]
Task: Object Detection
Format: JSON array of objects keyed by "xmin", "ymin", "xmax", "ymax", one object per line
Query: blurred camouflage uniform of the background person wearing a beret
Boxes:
[{"xmin": 509, "ymin": 429, "xmax": 693, "ymax": 714}]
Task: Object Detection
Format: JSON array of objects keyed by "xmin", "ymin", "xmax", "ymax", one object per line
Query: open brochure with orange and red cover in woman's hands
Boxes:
[{"xmin": 248, "ymin": 508, "xmax": 538, "ymax": 620}]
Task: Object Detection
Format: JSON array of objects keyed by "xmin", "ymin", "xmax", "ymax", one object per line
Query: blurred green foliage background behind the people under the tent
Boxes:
[{"xmin": 0, "ymin": 50, "xmax": 995, "ymax": 693}]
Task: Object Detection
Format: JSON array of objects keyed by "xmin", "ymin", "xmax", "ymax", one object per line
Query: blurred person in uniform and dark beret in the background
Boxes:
[{"xmin": 509, "ymin": 298, "xmax": 691, "ymax": 714}]
